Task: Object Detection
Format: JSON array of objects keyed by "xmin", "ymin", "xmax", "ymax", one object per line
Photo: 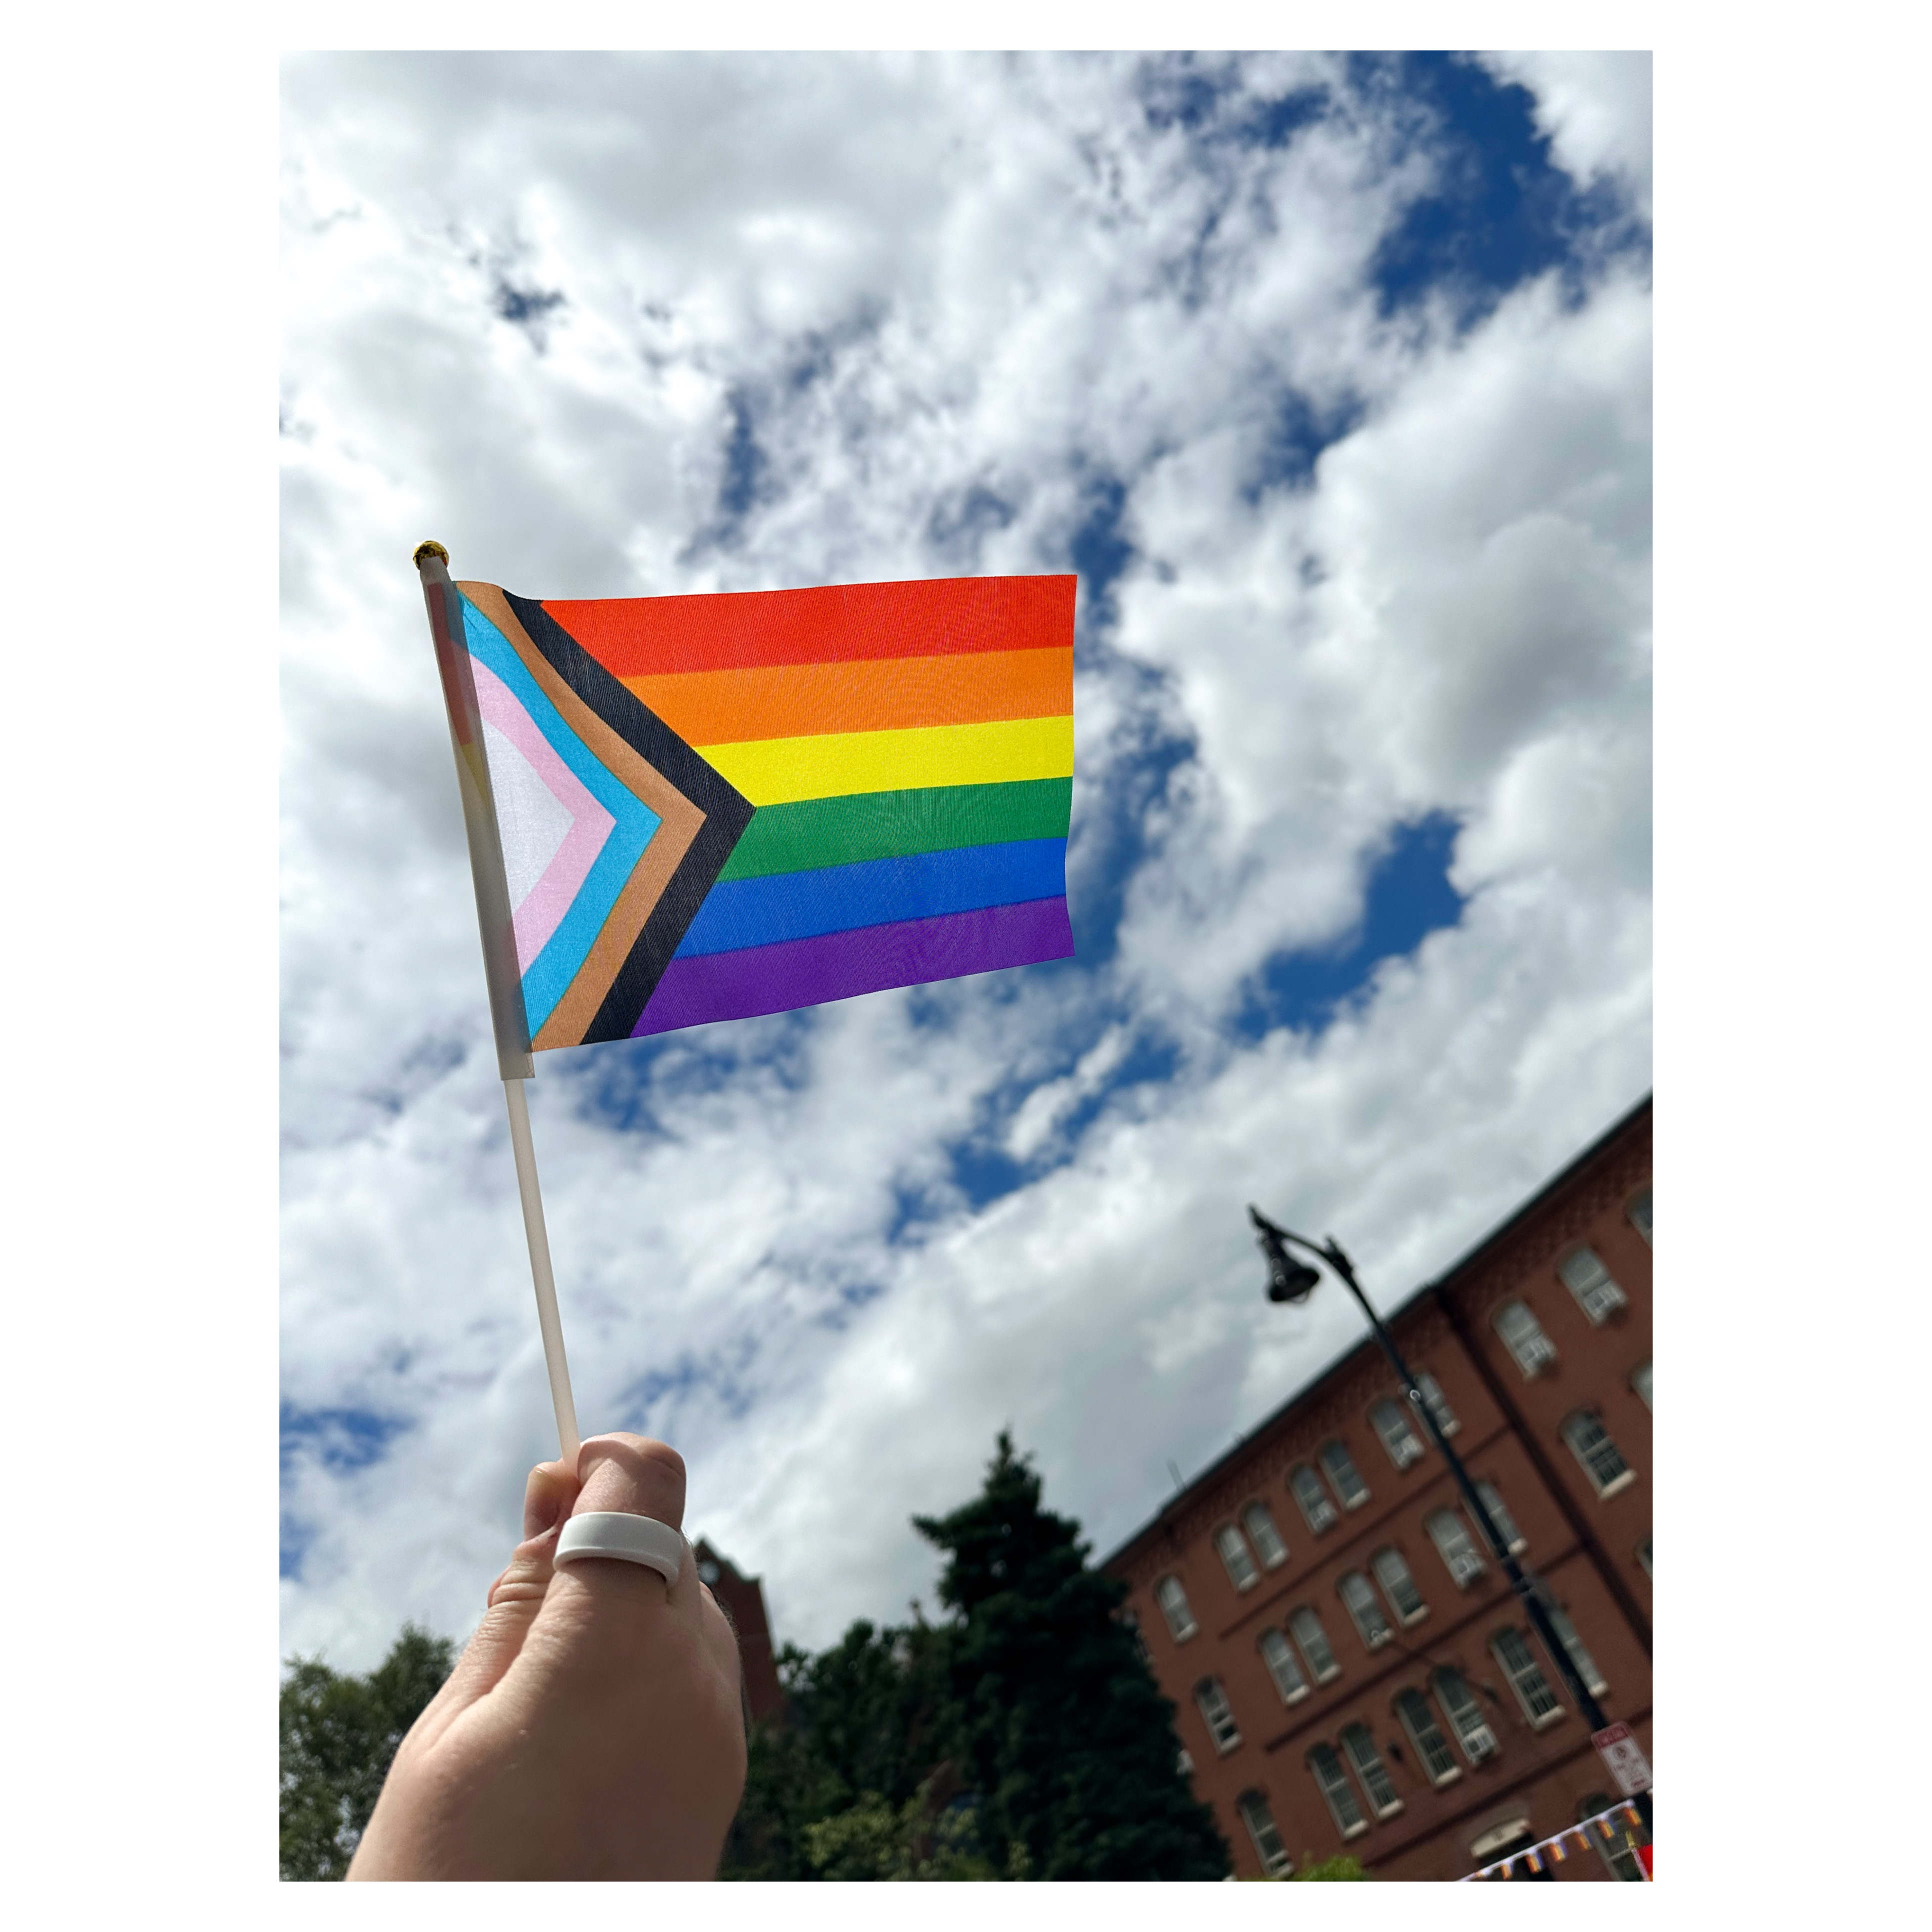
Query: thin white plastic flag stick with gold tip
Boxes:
[{"xmin": 415, "ymin": 543, "xmax": 581, "ymax": 1468}]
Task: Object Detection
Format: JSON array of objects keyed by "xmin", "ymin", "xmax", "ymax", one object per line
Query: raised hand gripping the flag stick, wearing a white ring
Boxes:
[{"xmin": 348, "ymin": 1436, "xmax": 746, "ymax": 1880}]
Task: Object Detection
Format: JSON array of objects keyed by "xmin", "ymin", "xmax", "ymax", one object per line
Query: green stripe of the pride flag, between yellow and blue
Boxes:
[{"xmin": 719, "ymin": 779, "xmax": 1074, "ymax": 883}]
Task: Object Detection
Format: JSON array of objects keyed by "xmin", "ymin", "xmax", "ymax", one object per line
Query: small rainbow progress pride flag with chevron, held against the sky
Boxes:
[{"xmin": 425, "ymin": 566, "xmax": 1076, "ymax": 1076}]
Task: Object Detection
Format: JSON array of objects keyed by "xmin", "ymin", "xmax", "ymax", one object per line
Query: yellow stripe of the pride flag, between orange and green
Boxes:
[{"xmin": 697, "ymin": 717, "xmax": 1074, "ymax": 806}]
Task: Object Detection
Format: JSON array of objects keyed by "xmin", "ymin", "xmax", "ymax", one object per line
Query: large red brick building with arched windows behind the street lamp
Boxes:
[{"xmin": 1103, "ymin": 1097, "xmax": 1650, "ymax": 1880}]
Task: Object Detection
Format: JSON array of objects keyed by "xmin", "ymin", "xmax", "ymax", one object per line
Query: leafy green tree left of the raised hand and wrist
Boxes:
[{"xmin": 282, "ymin": 1623, "xmax": 456, "ymax": 1880}]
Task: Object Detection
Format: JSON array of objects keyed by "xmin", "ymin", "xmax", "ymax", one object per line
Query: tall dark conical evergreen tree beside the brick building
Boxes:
[{"xmin": 914, "ymin": 1432, "xmax": 1229, "ymax": 1878}]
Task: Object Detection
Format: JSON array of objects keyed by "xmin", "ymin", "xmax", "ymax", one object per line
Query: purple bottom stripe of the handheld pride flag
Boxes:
[{"xmin": 632, "ymin": 898, "xmax": 1074, "ymax": 1039}]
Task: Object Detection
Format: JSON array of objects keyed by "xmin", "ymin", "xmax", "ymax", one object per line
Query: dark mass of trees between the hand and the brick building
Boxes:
[{"xmin": 721, "ymin": 1436, "xmax": 1229, "ymax": 1880}]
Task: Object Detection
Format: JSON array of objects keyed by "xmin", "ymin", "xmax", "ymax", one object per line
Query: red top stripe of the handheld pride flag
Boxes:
[{"xmin": 543, "ymin": 576, "xmax": 1078, "ymax": 678}]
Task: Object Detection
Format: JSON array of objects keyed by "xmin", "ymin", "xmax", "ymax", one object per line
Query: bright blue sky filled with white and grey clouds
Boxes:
[{"xmin": 282, "ymin": 54, "xmax": 1652, "ymax": 1667}]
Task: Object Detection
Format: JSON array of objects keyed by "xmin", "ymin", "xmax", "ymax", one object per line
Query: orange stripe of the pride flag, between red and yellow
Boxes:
[{"xmin": 624, "ymin": 645, "xmax": 1074, "ymax": 744}]
